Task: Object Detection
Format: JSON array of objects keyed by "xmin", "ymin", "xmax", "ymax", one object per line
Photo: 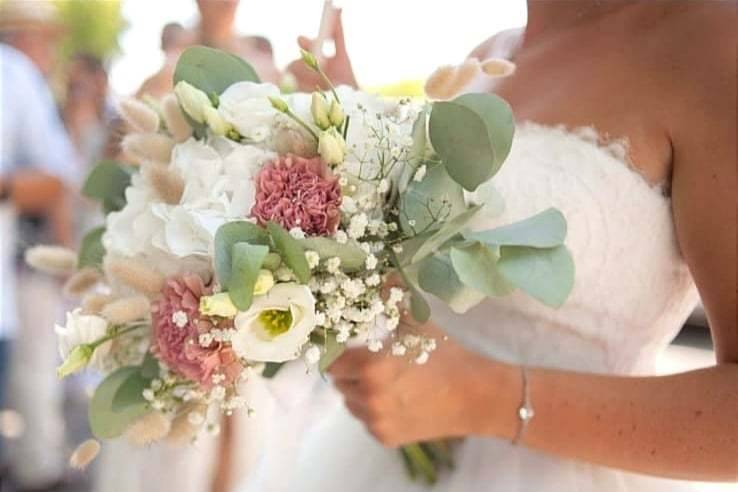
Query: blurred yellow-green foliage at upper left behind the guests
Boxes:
[{"xmin": 56, "ymin": 0, "xmax": 125, "ymax": 60}]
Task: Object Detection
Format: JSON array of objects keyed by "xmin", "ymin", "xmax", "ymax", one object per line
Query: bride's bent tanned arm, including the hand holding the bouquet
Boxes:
[{"xmin": 331, "ymin": 51, "xmax": 738, "ymax": 481}]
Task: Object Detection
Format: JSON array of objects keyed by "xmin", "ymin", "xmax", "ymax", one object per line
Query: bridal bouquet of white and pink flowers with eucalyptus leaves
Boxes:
[{"xmin": 29, "ymin": 47, "xmax": 573, "ymax": 476}]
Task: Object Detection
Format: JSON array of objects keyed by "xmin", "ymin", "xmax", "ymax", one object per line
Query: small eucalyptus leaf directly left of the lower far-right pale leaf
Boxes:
[{"xmin": 449, "ymin": 241, "xmax": 514, "ymax": 297}]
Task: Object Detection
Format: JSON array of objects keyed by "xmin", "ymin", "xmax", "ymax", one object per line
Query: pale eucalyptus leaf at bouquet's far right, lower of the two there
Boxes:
[{"xmin": 497, "ymin": 246, "xmax": 575, "ymax": 307}]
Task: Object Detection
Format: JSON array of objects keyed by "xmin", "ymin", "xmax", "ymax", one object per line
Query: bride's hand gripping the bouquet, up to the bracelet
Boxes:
[{"xmin": 329, "ymin": 323, "xmax": 519, "ymax": 447}]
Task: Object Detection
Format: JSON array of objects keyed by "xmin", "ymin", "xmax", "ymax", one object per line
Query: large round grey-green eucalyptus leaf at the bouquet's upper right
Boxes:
[{"xmin": 429, "ymin": 94, "xmax": 515, "ymax": 191}]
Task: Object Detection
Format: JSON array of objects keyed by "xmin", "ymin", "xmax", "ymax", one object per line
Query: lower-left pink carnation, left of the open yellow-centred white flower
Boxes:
[{"xmin": 151, "ymin": 274, "xmax": 242, "ymax": 389}]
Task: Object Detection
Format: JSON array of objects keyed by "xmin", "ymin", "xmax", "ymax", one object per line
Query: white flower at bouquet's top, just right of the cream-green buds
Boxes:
[{"xmin": 218, "ymin": 82, "xmax": 279, "ymax": 142}]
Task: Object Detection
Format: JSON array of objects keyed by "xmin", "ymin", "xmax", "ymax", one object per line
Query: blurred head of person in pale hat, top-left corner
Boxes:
[{"xmin": 0, "ymin": 0, "xmax": 62, "ymax": 75}]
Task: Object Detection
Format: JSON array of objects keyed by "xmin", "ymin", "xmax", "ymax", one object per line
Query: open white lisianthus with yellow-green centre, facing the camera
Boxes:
[{"xmin": 231, "ymin": 283, "xmax": 316, "ymax": 362}]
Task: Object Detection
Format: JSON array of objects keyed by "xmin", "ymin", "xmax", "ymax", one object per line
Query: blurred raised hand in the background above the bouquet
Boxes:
[{"xmin": 287, "ymin": 11, "xmax": 357, "ymax": 92}]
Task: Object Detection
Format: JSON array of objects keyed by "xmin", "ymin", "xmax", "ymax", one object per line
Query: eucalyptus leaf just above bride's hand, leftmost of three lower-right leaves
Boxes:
[{"xmin": 418, "ymin": 255, "xmax": 485, "ymax": 313}]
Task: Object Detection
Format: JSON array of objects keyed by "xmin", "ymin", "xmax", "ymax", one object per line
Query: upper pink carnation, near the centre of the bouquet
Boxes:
[{"xmin": 251, "ymin": 154, "xmax": 341, "ymax": 236}]
